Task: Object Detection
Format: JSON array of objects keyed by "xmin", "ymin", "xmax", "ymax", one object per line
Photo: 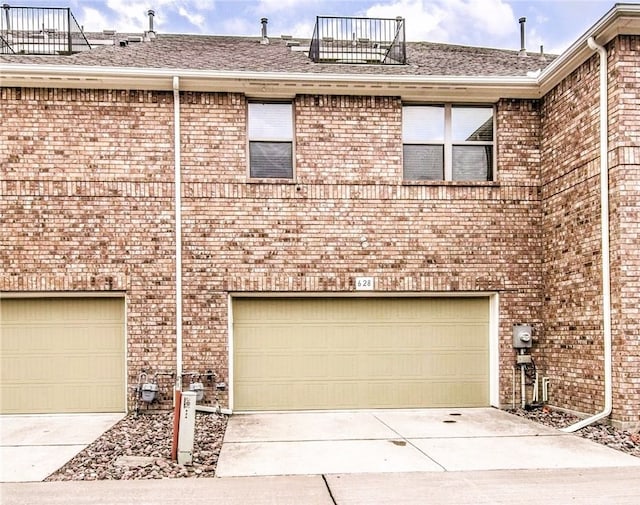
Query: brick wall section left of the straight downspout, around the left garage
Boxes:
[{"xmin": 0, "ymin": 89, "xmax": 175, "ymax": 410}]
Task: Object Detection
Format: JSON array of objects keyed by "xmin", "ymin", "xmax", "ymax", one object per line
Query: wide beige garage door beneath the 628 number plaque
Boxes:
[{"xmin": 233, "ymin": 298, "xmax": 489, "ymax": 411}]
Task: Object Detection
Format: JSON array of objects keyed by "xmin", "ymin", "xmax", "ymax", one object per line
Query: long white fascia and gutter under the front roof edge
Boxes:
[{"xmin": 0, "ymin": 64, "xmax": 539, "ymax": 101}]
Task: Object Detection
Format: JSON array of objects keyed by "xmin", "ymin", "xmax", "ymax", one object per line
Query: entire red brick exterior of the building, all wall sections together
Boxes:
[{"xmin": 0, "ymin": 34, "xmax": 640, "ymax": 421}]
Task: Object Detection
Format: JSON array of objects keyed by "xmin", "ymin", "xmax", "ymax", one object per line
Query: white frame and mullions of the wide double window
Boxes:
[{"xmin": 402, "ymin": 103, "xmax": 496, "ymax": 182}]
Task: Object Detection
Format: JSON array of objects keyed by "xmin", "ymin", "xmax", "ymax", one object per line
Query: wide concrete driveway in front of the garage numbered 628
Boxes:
[{"xmin": 216, "ymin": 408, "xmax": 640, "ymax": 477}]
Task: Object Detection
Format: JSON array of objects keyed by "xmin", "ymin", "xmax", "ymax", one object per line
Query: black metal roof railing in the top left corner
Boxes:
[{"xmin": 0, "ymin": 4, "xmax": 91, "ymax": 54}]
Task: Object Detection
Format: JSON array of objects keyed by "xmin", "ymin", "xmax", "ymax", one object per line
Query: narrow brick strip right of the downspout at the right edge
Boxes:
[{"xmin": 609, "ymin": 36, "xmax": 640, "ymax": 426}]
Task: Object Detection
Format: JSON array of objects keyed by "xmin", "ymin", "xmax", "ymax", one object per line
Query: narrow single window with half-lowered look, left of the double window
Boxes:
[{"xmin": 248, "ymin": 103, "xmax": 293, "ymax": 179}]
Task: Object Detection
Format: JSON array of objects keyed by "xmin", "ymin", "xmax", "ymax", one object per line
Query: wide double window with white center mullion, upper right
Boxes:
[{"xmin": 402, "ymin": 105, "xmax": 493, "ymax": 181}]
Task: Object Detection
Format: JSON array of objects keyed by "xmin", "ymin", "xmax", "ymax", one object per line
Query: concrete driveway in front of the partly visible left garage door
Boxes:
[{"xmin": 0, "ymin": 413, "xmax": 125, "ymax": 482}]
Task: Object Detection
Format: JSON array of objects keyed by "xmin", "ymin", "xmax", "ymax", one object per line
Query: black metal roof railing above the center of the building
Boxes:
[{"xmin": 309, "ymin": 16, "xmax": 407, "ymax": 65}]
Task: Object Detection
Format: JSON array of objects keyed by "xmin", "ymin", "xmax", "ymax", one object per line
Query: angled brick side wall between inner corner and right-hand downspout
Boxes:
[{"xmin": 541, "ymin": 56, "xmax": 603, "ymax": 413}]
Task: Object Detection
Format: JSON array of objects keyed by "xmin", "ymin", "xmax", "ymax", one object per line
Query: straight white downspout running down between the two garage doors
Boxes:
[{"xmin": 173, "ymin": 76, "xmax": 182, "ymax": 391}]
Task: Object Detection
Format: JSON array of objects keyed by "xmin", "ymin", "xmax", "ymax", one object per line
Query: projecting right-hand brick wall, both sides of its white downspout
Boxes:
[{"xmin": 541, "ymin": 37, "xmax": 640, "ymax": 424}]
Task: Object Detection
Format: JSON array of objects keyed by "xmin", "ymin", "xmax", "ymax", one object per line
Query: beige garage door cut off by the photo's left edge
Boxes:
[{"xmin": 0, "ymin": 298, "xmax": 126, "ymax": 414}]
